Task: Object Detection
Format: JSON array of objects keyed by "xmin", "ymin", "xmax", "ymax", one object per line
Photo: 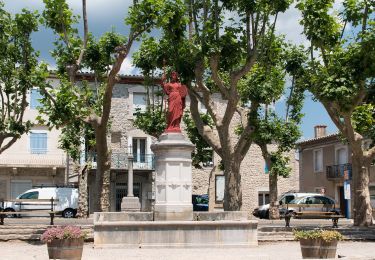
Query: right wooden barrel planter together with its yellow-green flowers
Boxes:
[{"xmin": 293, "ymin": 229, "xmax": 343, "ymax": 259}]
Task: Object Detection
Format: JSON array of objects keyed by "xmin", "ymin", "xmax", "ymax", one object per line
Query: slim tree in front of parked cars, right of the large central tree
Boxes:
[{"xmin": 238, "ymin": 43, "xmax": 306, "ymax": 219}]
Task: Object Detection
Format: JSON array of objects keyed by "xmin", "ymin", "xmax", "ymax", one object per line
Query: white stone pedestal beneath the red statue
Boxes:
[{"xmin": 151, "ymin": 133, "xmax": 194, "ymax": 221}]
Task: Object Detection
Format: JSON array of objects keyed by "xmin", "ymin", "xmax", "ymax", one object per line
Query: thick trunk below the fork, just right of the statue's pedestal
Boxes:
[{"xmin": 224, "ymin": 158, "xmax": 242, "ymax": 211}]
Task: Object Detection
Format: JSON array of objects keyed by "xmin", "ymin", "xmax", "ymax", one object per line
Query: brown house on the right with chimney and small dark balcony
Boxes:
[{"xmin": 298, "ymin": 126, "xmax": 375, "ymax": 217}]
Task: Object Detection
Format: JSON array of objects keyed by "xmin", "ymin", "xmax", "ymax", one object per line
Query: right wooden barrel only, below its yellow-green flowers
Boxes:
[{"xmin": 300, "ymin": 238, "xmax": 338, "ymax": 259}]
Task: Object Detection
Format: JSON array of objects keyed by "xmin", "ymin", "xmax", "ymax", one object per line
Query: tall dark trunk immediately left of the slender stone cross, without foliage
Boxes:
[{"xmin": 95, "ymin": 125, "xmax": 111, "ymax": 212}]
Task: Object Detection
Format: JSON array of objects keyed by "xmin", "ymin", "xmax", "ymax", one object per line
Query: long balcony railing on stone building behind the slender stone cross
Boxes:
[{"xmin": 90, "ymin": 153, "xmax": 155, "ymax": 170}]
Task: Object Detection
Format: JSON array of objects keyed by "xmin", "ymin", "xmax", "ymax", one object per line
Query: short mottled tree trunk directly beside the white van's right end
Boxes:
[{"xmin": 77, "ymin": 164, "xmax": 89, "ymax": 218}]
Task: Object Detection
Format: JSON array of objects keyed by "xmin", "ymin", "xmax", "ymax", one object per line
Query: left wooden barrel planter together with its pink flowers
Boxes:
[{"xmin": 41, "ymin": 226, "xmax": 87, "ymax": 259}]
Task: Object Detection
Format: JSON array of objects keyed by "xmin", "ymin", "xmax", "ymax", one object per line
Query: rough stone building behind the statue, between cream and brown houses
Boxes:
[{"xmin": 83, "ymin": 73, "xmax": 299, "ymax": 216}]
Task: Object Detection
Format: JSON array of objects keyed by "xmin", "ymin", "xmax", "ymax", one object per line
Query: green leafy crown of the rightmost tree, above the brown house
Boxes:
[{"xmin": 298, "ymin": 0, "xmax": 375, "ymax": 142}]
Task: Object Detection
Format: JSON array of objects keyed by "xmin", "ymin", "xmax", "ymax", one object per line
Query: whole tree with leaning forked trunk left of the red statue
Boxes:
[{"xmin": 39, "ymin": 0, "xmax": 188, "ymax": 211}]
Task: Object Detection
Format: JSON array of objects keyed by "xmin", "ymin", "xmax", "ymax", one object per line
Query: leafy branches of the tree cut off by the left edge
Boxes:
[{"xmin": 0, "ymin": 2, "xmax": 46, "ymax": 154}]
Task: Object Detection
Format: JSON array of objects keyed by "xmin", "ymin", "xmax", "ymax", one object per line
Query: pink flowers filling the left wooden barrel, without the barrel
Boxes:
[{"xmin": 40, "ymin": 226, "xmax": 87, "ymax": 243}]
